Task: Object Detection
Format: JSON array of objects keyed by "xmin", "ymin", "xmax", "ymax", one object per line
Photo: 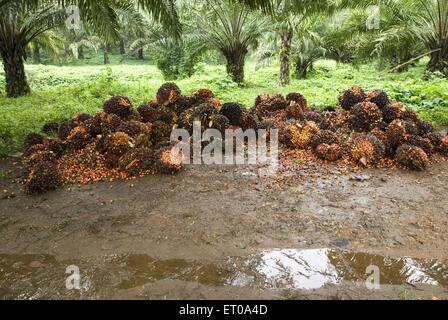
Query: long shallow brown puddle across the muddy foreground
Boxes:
[{"xmin": 0, "ymin": 249, "xmax": 448, "ymax": 300}]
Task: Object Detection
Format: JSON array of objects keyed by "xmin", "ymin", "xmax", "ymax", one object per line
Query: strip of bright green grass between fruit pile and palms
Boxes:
[{"xmin": 0, "ymin": 56, "xmax": 448, "ymax": 155}]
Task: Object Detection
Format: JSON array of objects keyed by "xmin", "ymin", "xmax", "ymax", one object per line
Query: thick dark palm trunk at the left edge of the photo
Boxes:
[{"xmin": 1, "ymin": 48, "xmax": 31, "ymax": 97}]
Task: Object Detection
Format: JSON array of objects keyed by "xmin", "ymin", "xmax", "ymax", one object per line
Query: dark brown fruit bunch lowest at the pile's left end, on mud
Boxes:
[{"xmin": 25, "ymin": 160, "xmax": 61, "ymax": 194}]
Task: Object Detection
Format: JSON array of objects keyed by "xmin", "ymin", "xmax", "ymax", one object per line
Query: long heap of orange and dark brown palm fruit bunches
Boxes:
[{"xmin": 23, "ymin": 83, "xmax": 448, "ymax": 193}]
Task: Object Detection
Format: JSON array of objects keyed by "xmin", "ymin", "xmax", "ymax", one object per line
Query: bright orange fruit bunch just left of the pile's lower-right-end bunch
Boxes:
[{"xmin": 349, "ymin": 134, "xmax": 385, "ymax": 167}]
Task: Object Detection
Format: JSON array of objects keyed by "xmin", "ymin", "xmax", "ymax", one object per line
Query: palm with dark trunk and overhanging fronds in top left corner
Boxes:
[{"xmin": 0, "ymin": 0, "xmax": 180, "ymax": 97}]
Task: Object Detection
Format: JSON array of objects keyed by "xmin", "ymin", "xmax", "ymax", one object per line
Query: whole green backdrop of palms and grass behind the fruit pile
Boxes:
[{"xmin": 0, "ymin": 0, "xmax": 448, "ymax": 155}]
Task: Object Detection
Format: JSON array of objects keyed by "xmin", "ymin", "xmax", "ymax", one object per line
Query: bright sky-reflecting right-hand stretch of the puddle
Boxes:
[{"xmin": 247, "ymin": 249, "xmax": 448, "ymax": 289}]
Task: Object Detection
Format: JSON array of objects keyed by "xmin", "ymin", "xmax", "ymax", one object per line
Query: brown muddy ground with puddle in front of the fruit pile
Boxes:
[{"xmin": 0, "ymin": 158, "xmax": 448, "ymax": 299}]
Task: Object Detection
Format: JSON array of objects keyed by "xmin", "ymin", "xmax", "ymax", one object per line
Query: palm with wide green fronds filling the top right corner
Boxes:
[{"xmin": 312, "ymin": 0, "xmax": 448, "ymax": 76}]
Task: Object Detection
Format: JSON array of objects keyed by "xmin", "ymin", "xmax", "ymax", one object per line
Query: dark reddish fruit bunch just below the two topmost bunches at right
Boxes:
[{"xmin": 349, "ymin": 102, "xmax": 383, "ymax": 131}]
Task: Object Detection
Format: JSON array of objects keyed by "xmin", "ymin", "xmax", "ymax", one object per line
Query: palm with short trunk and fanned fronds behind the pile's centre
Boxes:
[{"xmin": 198, "ymin": 1, "xmax": 267, "ymax": 84}]
